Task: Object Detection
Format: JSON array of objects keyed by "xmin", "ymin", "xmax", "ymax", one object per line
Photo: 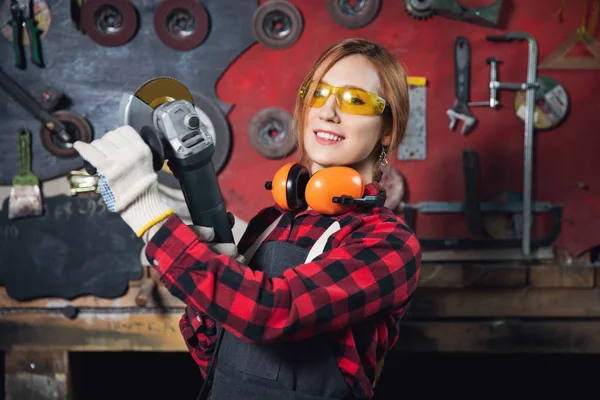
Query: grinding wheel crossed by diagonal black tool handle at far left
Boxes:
[{"xmin": 40, "ymin": 110, "xmax": 93, "ymax": 157}]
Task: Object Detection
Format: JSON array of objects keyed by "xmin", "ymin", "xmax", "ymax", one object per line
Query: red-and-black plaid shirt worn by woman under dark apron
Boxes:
[{"xmin": 146, "ymin": 184, "xmax": 421, "ymax": 398}]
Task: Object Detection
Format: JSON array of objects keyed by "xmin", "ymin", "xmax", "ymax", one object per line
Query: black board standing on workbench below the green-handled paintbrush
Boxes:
[{"xmin": 0, "ymin": 195, "xmax": 143, "ymax": 300}]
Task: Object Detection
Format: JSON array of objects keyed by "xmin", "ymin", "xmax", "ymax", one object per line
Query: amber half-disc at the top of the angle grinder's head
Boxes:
[{"xmin": 134, "ymin": 76, "xmax": 194, "ymax": 109}]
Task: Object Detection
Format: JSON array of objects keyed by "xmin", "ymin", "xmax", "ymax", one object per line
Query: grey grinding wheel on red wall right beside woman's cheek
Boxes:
[{"xmin": 248, "ymin": 107, "xmax": 296, "ymax": 159}]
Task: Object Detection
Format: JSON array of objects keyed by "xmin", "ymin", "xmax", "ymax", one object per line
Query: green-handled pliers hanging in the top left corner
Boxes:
[{"xmin": 10, "ymin": 0, "xmax": 44, "ymax": 69}]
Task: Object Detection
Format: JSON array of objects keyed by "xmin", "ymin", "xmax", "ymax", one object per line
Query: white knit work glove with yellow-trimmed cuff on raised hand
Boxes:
[{"xmin": 73, "ymin": 126, "xmax": 173, "ymax": 237}]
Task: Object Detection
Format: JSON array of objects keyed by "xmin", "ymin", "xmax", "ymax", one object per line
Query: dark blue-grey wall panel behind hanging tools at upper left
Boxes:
[{"xmin": 0, "ymin": 0, "xmax": 258, "ymax": 185}]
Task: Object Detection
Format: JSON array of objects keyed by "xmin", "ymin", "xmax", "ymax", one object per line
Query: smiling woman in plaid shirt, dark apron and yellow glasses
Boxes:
[{"xmin": 75, "ymin": 39, "xmax": 421, "ymax": 399}]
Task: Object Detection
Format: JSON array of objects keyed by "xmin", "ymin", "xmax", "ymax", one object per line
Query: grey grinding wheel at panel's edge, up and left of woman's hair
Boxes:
[{"xmin": 252, "ymin": 0, "xmax": 304, "ymax": 50}]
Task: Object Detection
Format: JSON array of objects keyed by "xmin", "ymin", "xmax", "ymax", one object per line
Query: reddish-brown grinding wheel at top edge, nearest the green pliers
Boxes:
[{"xmin": 81, "ymin": 0, "xmax": 138, "ymax": 47}]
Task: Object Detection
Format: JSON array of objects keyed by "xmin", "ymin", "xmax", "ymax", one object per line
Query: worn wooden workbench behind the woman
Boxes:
[{"xmin": 0, "ymin": 257, "xmax": 600, "ymax": 399}]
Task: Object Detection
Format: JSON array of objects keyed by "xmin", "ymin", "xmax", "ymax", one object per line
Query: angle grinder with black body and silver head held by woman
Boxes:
[{"xmin": 85, "ymin": 77, "xmax": 234, "ymax": 243}]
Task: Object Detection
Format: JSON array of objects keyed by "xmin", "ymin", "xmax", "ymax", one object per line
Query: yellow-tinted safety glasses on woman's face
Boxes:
[{"xmin": 300, "ymin": 82, "xmax": 387, "ymax": 115}]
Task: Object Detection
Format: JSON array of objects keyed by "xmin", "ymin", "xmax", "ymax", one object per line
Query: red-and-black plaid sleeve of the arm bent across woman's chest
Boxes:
[{"xmin": 146, "ymin": 213, "xmax": 421, "ymax": 343}]
